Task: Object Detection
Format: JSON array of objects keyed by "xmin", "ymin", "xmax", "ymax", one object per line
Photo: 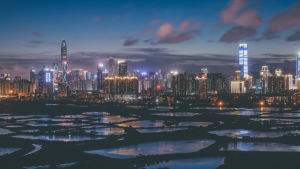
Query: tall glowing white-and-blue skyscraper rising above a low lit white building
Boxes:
[{"xmin": 239, "ymin": 43, "xmax": 248, "ymax": 79}]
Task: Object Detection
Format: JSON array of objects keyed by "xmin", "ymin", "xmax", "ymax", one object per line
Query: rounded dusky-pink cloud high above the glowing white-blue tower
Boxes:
[{"xmin": 233, "ymin": 9, "xmax": 263, "ymax": 27}]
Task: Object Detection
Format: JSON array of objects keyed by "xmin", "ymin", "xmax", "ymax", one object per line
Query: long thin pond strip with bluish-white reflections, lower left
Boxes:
[{"xmin": 12, "ymin": 135, "xmax": 105, "ymax": 142}]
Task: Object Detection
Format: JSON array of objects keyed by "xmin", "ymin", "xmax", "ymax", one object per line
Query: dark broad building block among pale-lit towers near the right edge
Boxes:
[{"xmin": 267, "ymin": 76, "xmax": 285, "ymax": 94}]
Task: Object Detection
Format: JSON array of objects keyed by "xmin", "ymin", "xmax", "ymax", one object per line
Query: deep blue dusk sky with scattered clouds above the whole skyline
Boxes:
[{"xmin": 0, "ymin": 0, "xmax": 300, "ymax": 79}]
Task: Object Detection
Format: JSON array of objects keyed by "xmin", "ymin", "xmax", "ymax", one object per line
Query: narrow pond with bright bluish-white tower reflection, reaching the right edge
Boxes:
[{"xmin": 209, "ymin": 129, "xmax": 300, "ymax": 138}]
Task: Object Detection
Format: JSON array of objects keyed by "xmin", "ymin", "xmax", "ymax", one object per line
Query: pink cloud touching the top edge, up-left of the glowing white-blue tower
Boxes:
[{"xmin": 220, "ymin": 0, "xmax": 247, "ymax": 23}]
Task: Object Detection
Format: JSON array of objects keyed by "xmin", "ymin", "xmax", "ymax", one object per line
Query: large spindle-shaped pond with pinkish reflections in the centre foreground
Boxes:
[{"xmin": 85, "ymin": 140, "xmax": 215, "ymax": 158}]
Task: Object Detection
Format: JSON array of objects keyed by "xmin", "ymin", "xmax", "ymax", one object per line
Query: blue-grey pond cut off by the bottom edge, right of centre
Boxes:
[{"xmin": 145, "ymin": 157, "xmax": 225, "ymax": 169}]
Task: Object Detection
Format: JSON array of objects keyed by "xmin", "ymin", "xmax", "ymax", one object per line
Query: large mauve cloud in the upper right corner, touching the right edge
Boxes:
[{"xmin": 267, "ymin": 3, "xmax": 300, "ymax": 34}]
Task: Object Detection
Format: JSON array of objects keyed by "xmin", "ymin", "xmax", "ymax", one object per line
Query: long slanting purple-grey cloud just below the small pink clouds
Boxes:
[{"xmin": 151, "ymin": 30, "xmax": 200, "ymax": 45}]
